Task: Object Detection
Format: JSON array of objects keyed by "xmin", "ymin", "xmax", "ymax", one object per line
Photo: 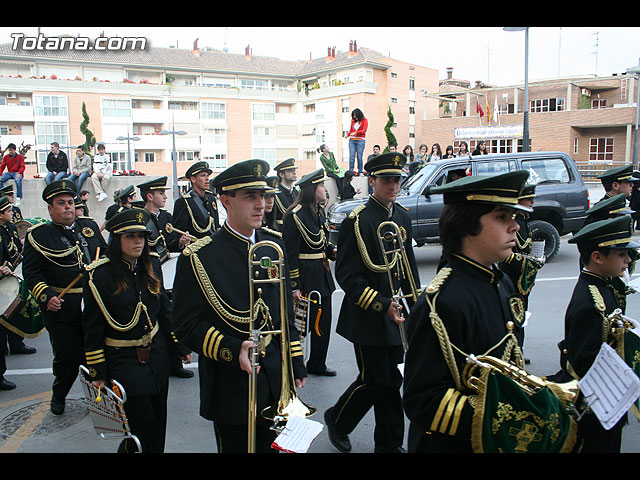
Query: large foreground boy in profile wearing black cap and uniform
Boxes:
[{"xmin": 403, "ymin": 171, "xmax": 552, "ymax": 453}]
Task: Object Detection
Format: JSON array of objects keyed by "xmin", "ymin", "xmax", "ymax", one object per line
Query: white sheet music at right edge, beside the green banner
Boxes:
[{"xmin": 578, "ymin": 343, "xmax": 640, "ymax": 430}]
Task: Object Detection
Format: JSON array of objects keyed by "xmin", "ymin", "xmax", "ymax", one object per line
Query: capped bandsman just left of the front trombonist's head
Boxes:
[{"xmin": 173, "ymin": 160, "xmax": 220, "ymax": 238}]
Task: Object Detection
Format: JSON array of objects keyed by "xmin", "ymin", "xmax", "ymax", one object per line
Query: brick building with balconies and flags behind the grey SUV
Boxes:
[{"xmin": 419, "ymin": 69, "xmax": 638, "ymax": 175}]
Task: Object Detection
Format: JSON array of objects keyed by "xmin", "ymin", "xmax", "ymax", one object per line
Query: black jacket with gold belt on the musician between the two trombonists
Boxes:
[{"xmin": 282, "ymin": 205, "xmax": 336, "ymax": 297}]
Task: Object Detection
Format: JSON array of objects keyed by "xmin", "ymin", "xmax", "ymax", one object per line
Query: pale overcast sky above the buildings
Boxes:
[{"xmin": 0, "ymin": 26, "xmax": 640, "ymax": 86}]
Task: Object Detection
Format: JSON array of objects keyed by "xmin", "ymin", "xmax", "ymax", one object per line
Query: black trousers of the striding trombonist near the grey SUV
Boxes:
[{"xmin": 333, "ymin": 344, "xmax": 404, "ymax": 449}]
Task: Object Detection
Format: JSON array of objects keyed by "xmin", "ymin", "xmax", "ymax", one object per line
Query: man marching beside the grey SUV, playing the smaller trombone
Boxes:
[{"xmin": 324, "ymin": 153, "xmax": 420, "ymax": 452}]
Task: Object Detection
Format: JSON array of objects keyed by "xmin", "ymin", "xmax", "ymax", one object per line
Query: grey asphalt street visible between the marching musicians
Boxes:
[{"xmin": 0, "ymin": 231, "xmax": 640, "ymax": 453}]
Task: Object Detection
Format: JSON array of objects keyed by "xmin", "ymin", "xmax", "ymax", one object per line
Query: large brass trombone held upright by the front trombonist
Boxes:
[{"xmin": 248, "ymin": 240, "xmax": 316, "ymax": 453}]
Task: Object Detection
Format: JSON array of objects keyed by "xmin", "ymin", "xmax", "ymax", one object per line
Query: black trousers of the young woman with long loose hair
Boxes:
[{"xmin": 118, "ymin": 382, "xmax": 169, "ymax": 453}]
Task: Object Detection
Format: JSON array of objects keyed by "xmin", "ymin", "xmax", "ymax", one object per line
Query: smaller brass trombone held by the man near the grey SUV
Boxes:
[{"xmin": 377, "ymin": 220, "xmax": 418, "ymax": 353}]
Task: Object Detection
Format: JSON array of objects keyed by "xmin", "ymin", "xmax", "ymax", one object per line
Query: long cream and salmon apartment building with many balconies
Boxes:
[{"xmin": 0, "ymin": 36, "xmax": 439, "ymax": 178}]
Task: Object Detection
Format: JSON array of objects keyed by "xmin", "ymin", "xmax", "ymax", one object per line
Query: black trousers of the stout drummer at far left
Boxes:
[{"xmin": 43, "ymin": 294, "xmax": 85, "ymax": 400}]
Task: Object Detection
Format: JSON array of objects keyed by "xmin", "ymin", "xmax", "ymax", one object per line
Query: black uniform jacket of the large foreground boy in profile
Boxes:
[{"xmin": 403, "ymin": 254, "xmax": 524, "ymax": 450}]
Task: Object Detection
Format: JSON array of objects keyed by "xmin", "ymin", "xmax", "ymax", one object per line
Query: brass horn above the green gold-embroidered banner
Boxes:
[{"xmin": 461, "ymin": 355, "xmax": 579, "ymax": 413}]
